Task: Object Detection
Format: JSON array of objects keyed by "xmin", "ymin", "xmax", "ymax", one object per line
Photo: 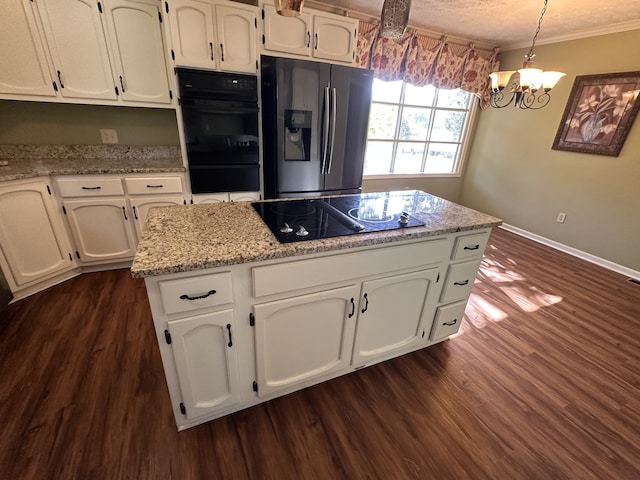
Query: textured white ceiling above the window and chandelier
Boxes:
[{"xmin": 314, "ymin": 0, "xmax": 640, "ymax": 49}]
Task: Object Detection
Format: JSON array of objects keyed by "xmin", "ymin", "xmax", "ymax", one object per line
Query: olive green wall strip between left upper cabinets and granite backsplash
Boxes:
[{"xmin": 0, "ymin": 100, "xmax": 180, "ymax": 145}]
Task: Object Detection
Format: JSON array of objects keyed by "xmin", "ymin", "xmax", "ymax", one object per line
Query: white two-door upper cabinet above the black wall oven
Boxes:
[{"xmin": 166, "ymin": 0, "xmax": 258, "ymax": 74}]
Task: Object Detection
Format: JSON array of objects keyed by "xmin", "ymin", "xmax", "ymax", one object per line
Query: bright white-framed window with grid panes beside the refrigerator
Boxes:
[{"xmin": 364, "ymin": 79, "xmax": 475, "ymax": 176}]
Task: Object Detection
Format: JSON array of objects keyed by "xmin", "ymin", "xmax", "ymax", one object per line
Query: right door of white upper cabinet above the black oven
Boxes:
[{"xmin": 216, "ymin": 5, "xmax": 258, "ymax": 73}]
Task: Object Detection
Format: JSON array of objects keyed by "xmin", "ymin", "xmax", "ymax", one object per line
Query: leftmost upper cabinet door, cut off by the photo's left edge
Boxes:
[{"xmin": 0, "ymin": 0, "xmax": 56, "ymax": 97}]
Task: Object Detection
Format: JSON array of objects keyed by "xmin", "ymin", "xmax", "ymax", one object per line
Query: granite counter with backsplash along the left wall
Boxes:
[{"xmin": 0, "ymin": 145, "xmax": 185, "ymax": 182}]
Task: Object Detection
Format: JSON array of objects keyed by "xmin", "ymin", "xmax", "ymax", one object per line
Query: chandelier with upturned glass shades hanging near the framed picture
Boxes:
[{"xmin": 489, "ymin": 0, "xmax": 565, "ymax": 110}]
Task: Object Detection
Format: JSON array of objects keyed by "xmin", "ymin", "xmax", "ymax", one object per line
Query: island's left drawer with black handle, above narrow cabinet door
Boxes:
[{"xmin": 158, "ymin": 273, "xmax": 233, "ymax": 315}]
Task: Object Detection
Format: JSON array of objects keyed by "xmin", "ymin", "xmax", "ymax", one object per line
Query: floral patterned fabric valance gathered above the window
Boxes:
[{"xmin": 356, "ymin": 21, "xmax": 500, "ymax": 108}]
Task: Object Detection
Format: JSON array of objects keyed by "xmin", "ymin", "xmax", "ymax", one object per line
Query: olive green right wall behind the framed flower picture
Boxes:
[{"xmin": 460, "ymin": 30, "xmax": 640, "ymax": 271}]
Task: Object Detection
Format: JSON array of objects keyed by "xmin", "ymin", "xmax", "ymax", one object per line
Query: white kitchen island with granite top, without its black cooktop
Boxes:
[{"xmin": 132, "ymin": 191, "xmax": 501, "ymax": 429}]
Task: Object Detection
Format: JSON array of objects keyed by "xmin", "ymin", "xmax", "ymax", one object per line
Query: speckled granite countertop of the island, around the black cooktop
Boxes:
[{"xmin": 131, "ymin": 192, "xmax": 502, "ymax": 278}]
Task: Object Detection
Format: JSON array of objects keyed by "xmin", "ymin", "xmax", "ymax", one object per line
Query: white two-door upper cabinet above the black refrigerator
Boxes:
[{"xmin": 262, "ymin": 3, "xmax": 358, "ymax": 64}]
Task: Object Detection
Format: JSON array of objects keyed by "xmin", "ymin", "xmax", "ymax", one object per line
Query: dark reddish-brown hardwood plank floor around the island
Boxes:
[{"xmin": 0, "ymin": 229, "xmax": 640, "ymax": 480}]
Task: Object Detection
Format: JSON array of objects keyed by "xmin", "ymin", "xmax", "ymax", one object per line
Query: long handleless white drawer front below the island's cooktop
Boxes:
[{"xmin": 252, "ymin": 238, "xmax": 451, "ymax": 297}]
